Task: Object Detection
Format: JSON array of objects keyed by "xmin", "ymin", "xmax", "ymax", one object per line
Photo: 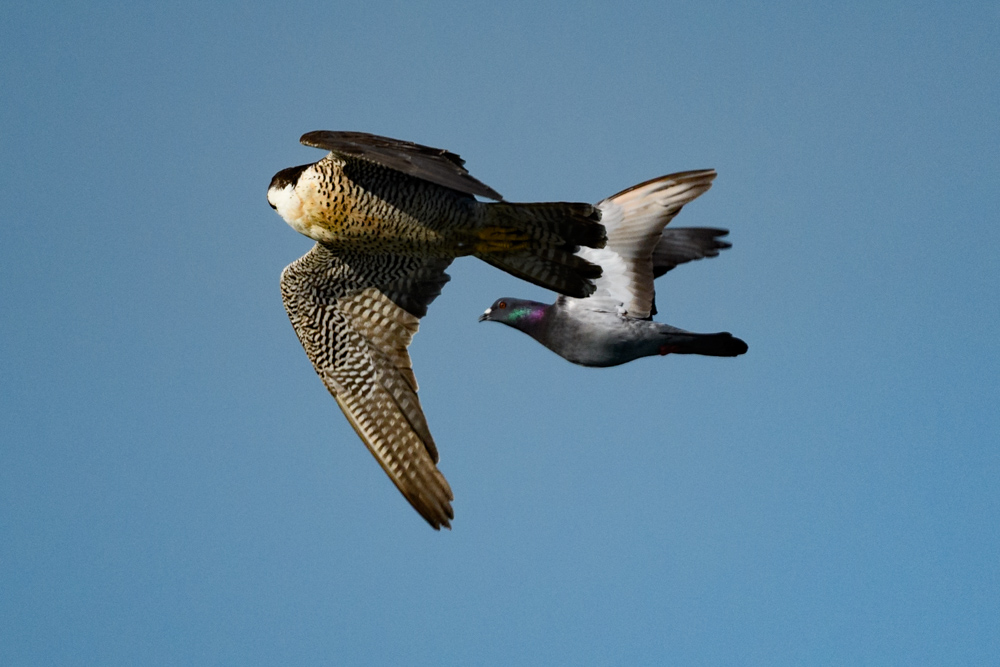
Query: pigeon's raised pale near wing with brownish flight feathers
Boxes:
[{"xmin": 577, "ymin": 169, "xmax": 715, "ymax": 319}]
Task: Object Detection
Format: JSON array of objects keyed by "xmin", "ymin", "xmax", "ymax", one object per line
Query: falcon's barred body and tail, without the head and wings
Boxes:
[{"xmin": 293, "ymin": 153, "xmax": 606, "ymax": 297}]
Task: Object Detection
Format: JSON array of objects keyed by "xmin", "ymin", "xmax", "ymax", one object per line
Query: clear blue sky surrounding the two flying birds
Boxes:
[{"xmin": 0, "ymin": 2, "xmax": 1000, "ymax": 665}]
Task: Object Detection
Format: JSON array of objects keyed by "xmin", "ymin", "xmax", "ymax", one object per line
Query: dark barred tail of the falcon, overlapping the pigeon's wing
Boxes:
[{"xmin": 474, "ymin": 202, "xmax": 607, "ymax": 298}]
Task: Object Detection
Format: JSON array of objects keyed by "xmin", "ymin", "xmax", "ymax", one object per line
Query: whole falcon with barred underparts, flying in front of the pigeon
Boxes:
[{"xmin": 267, "ymin": 131, "xmax": 606, "ymax": 529}]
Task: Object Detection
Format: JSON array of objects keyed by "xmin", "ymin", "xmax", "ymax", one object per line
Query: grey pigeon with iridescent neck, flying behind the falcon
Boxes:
[{"xmin": 479, "ymin": 169, "xmax": 747, "ymax": 367}]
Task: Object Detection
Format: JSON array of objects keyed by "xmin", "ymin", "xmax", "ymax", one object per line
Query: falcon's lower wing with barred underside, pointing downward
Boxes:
[{"xmin": 281, "ymin": 243, "xmax": 454, "ymax": 529}]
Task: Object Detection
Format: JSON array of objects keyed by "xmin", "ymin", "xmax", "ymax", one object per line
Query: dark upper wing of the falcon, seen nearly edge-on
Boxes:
[{"xmin": 300, "ymin": 130, "xmax": 503, "ymax": 200}]
